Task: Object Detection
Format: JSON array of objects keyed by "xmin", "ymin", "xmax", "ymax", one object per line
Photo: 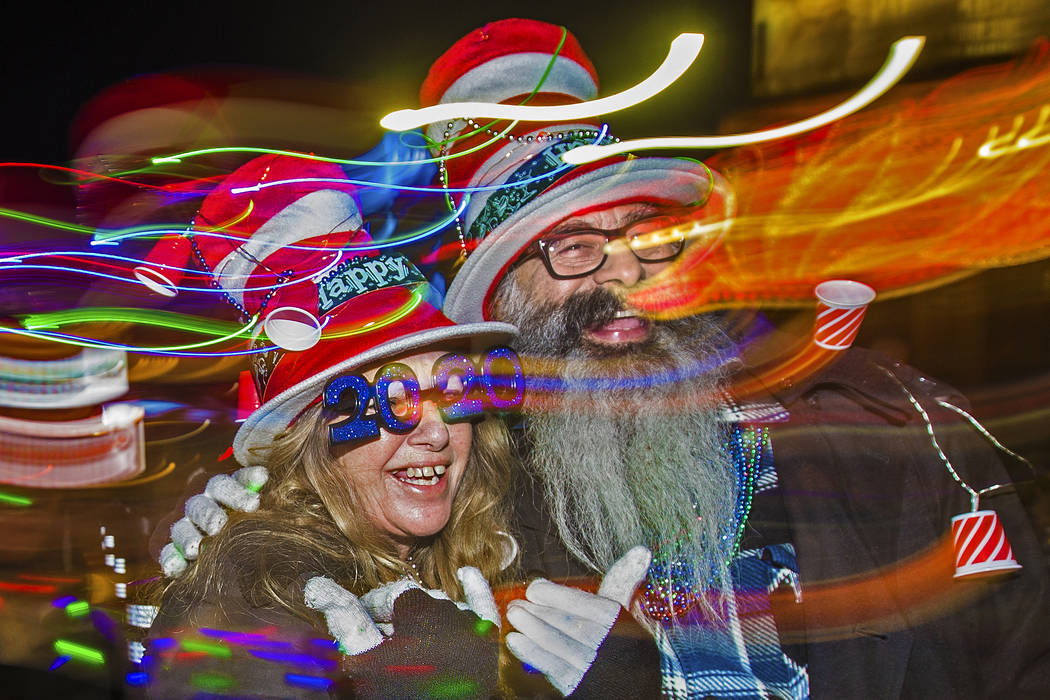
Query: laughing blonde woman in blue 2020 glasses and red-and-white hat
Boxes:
[{"xmin": 135, "ymin": 155, "xmax": 524, "ymax": 698}]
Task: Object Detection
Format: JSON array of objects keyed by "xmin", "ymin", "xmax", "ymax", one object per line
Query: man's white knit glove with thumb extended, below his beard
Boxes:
[{"xmin": 507, "ymin": 546, "xmax": 652, "ymax": 695}]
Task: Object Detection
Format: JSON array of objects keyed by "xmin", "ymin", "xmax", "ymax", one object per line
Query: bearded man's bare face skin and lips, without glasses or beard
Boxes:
[{"xmin": 512, "ymin": 203, "xmax": 671, "ymax": 352}]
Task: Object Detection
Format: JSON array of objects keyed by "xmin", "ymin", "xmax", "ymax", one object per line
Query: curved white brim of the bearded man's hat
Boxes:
[{"xmin": 442, "ymin": 157, "xmax": 735, "ymax": 323}]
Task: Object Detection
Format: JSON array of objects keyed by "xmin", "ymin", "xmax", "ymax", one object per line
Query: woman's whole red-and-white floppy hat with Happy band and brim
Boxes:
[{"xmin": 135, "ymin": 155, "xmax": 517, "ymax": 466}]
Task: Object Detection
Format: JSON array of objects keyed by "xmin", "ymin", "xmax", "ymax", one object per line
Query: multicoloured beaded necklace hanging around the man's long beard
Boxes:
[{"xmin": 642, "ymin": 423, "xmax": 769, "ymax": 622}]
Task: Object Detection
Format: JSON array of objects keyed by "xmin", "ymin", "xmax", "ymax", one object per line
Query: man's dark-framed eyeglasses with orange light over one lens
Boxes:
[{"xmin": 521, "ymin": 210, "xmax": 696, "ymax": 279}]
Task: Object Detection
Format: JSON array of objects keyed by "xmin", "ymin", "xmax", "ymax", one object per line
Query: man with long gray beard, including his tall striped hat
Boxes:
[{"xmin": 420, "ymin": 20, "xmax": 1050, "ymax": 698}]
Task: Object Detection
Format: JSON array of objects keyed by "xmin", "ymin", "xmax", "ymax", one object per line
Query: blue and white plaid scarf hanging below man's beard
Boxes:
[{"xmin": 656, "ymin": 434, "xmax": 810, "ymax": 700}]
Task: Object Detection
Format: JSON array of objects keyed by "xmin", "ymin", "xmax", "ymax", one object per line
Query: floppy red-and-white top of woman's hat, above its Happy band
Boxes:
[{"xmin": 134, "ymin": 155, "xmax": 371, "ymax": 351}]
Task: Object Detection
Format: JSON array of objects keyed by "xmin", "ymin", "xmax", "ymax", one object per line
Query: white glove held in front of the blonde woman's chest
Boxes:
[{"xmin": 303, "ymin": 567, "xmax": 500, "ymax": 656}]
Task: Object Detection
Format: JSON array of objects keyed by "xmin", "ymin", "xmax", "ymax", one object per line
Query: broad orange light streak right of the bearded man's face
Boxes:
[{"xmin": 628, "ymin": 42, "xmax": 1050, "ymax": 317}]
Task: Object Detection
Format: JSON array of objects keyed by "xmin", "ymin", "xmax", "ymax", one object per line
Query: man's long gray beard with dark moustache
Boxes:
[{"xmin": 492, "ymin": 274, "xmax": 737, "ymax": 612}]
